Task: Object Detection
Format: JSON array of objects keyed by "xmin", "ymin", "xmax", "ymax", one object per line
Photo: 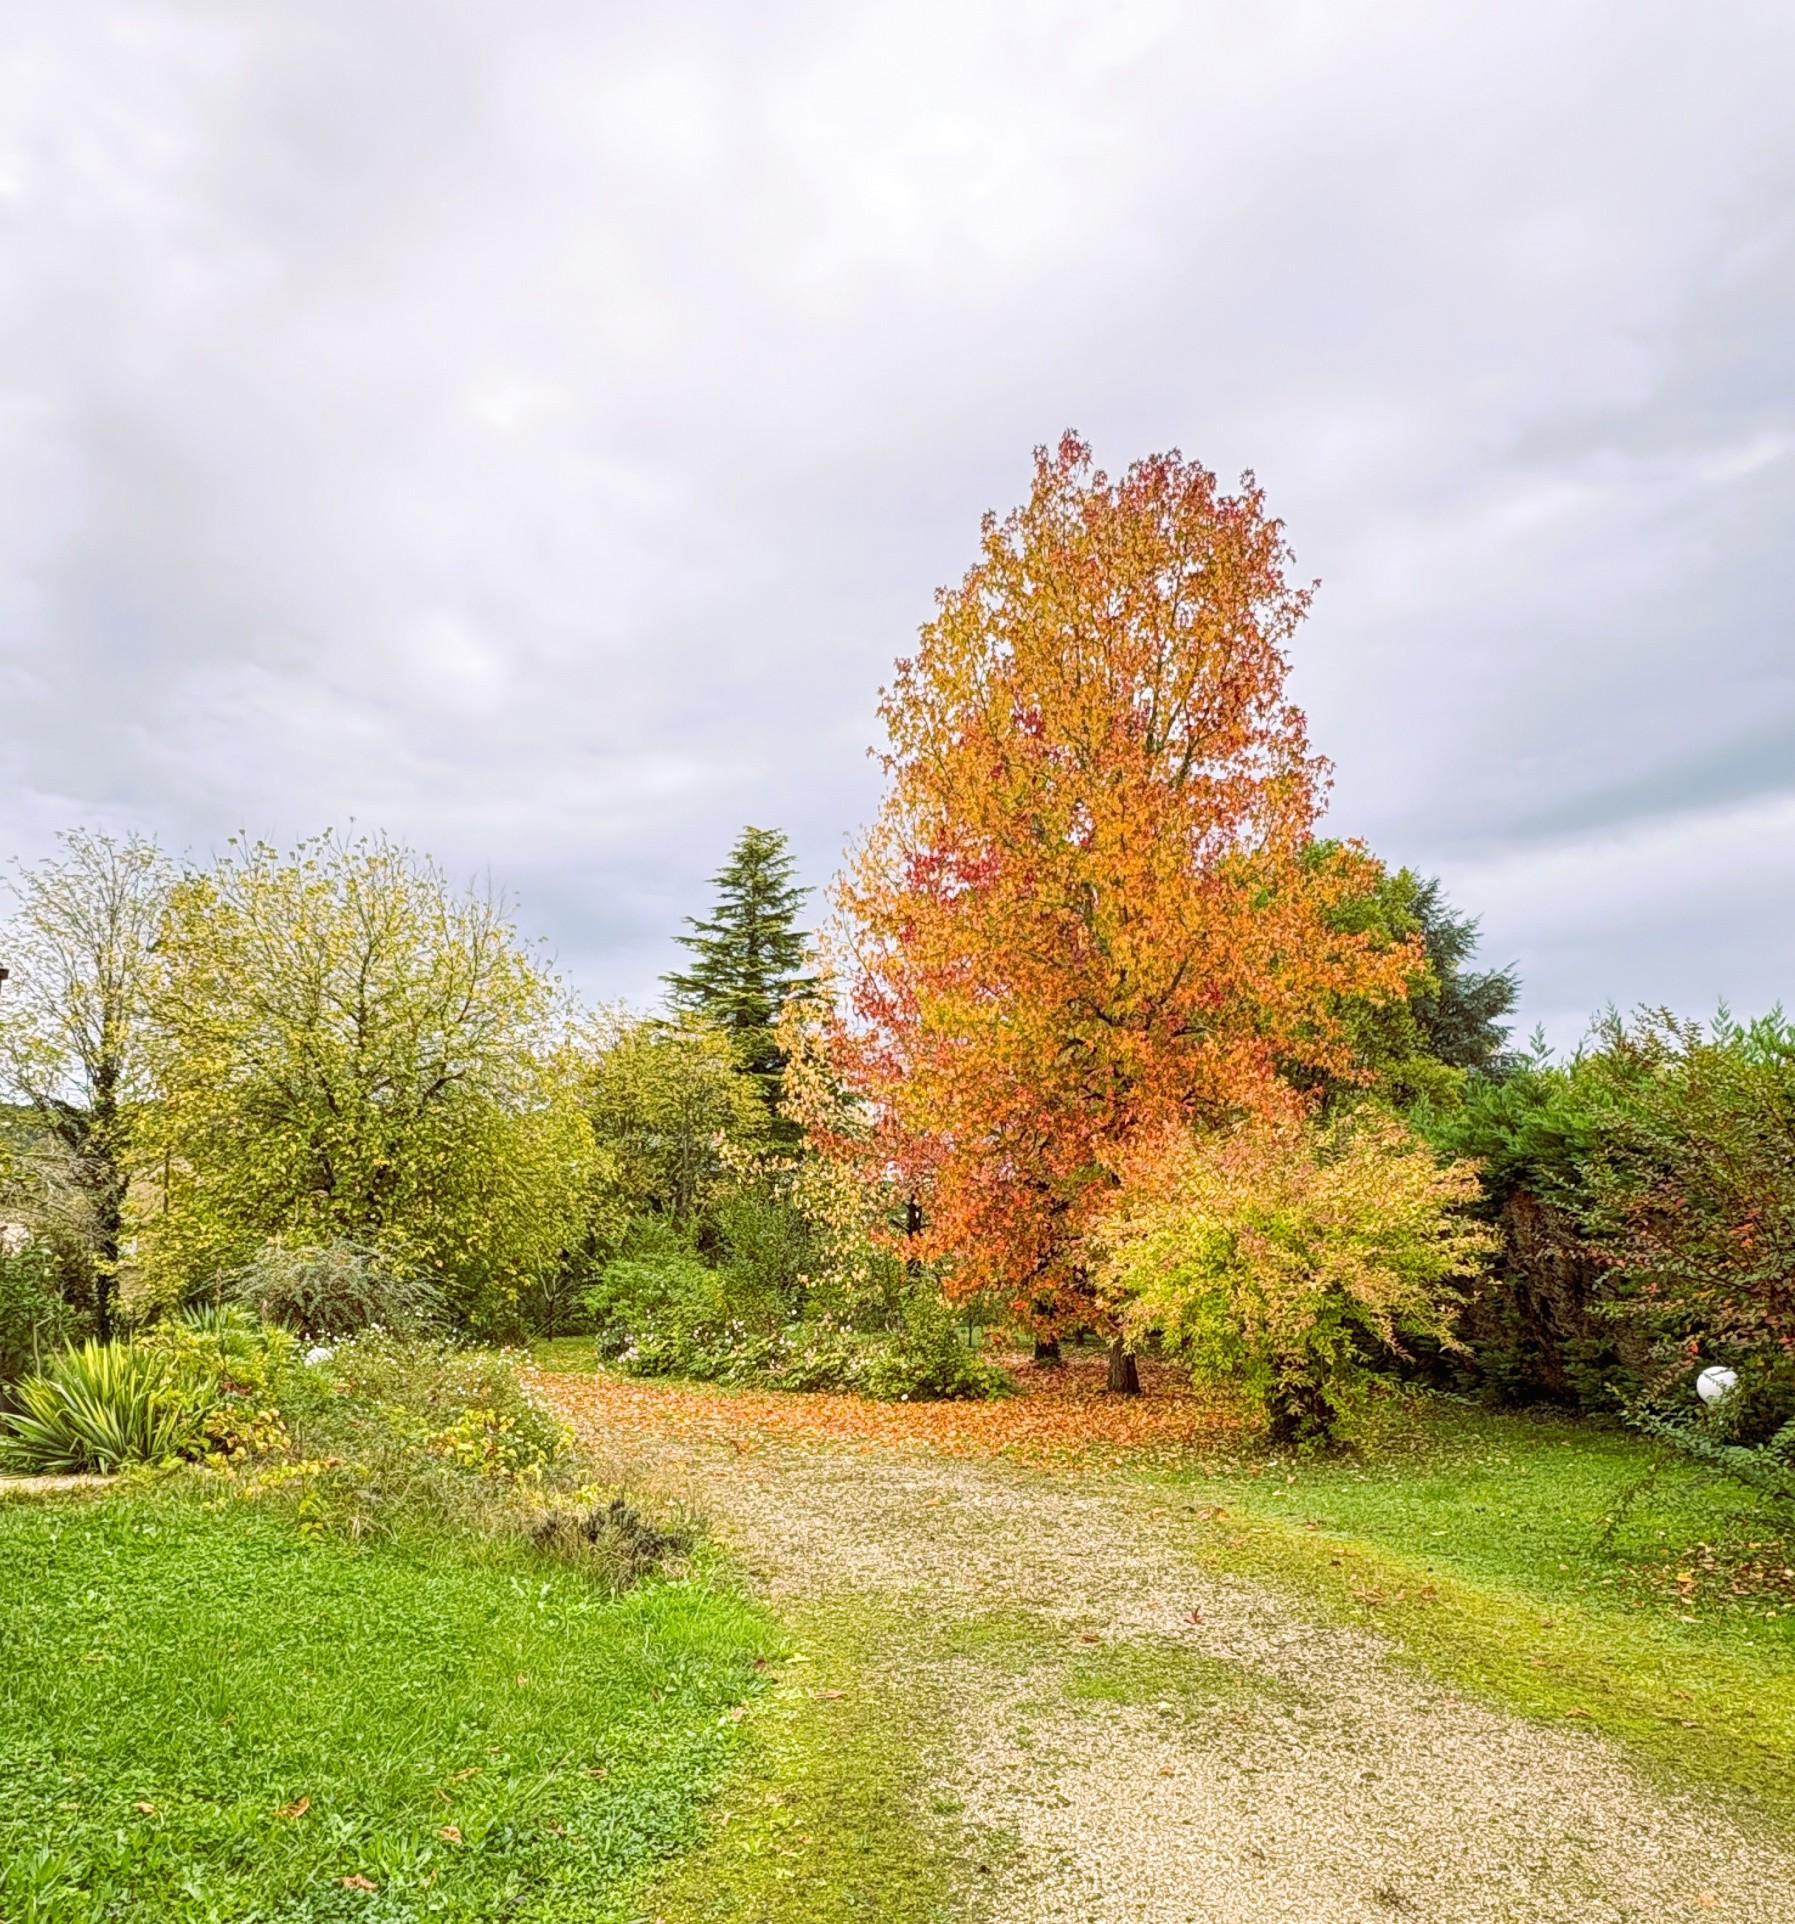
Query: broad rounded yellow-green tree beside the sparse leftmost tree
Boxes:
[{"xmin": 139, "ymin": 835, "xmax": 598, "ymax": 1331}]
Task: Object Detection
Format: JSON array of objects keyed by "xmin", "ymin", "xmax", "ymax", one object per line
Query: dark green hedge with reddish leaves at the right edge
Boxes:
[{"xmin": 1426, "ymin": 1010, "xmax": 1795, "ymax": 1416}]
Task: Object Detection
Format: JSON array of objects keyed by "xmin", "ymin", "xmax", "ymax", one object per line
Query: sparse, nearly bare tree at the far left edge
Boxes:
[{"xmin": 0, "ymin": 829, "xmax": 171, "ymax": 1337}]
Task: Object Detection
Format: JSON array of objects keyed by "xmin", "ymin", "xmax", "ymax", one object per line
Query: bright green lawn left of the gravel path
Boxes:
[{"xmin": 0, "ymin": 1495, "xmax": 779, "ymax": 1924}]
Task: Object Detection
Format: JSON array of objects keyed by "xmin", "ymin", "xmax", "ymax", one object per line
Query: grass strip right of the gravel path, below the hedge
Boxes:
[{"xmin": 1156, "ymin": 1399, "xmax": 1795, "ymax": 1826}]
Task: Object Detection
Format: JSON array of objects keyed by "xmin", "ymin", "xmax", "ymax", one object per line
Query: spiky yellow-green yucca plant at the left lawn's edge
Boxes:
[{"xmin": 0, "ymin": 1343, "xmax": 217, "ymax": 1476}]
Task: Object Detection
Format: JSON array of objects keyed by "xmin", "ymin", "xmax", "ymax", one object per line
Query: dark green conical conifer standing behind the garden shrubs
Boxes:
[{"xmin": 662, "ymin": 827, "xmax": 812, "ymax": 1114}]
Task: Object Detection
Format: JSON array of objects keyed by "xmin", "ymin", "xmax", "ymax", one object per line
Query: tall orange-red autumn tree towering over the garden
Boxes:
[{"xmin": 837, "ymin": 435, "xmax": 1418, "ymax": 1389}]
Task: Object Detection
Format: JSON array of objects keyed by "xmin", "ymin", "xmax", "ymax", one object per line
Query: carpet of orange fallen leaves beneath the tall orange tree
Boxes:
[{"xmin": 537, "ymin": 1356, "xmax": 1243, "ymax": 1469}]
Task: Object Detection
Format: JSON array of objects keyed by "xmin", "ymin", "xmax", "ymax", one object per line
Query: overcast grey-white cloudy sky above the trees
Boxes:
[{"xmin": 0, "ymin": 0, "xmax": 1795, "ymax": 1043}]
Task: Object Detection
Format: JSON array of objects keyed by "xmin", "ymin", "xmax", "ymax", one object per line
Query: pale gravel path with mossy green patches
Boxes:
[{"xmin": 557, "ymin": 1400, "xmax": 1795, "ymax": 1924}]
